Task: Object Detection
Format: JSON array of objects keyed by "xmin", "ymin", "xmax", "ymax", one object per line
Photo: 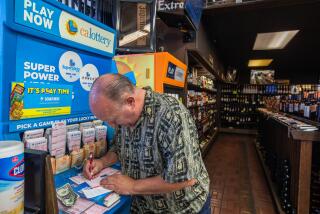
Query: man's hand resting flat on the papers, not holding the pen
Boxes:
[{"xmin": 100, "ymin": 174, "xmax": 135, "ymax": 195}]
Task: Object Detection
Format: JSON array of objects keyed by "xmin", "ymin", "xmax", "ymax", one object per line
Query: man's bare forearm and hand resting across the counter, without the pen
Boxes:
[{"xmin": 101, "ymin": 174, "xmax": 196, "ymax": 195}]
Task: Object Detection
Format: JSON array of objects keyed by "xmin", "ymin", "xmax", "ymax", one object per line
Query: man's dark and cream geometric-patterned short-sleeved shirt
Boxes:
[{"xmin": 111, "ymin": 88, "xmax": 210, "ymax": 214}]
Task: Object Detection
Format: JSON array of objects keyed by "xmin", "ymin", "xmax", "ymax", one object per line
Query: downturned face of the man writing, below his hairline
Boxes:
[{"xmin": 90, "ymin": 96, "xmax": 135, "ymax": 127}]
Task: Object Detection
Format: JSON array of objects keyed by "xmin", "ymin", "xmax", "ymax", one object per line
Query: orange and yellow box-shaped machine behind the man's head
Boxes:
[{"xmin": 114, "ymin": 52, "xmax": 187, "ymax": 102}]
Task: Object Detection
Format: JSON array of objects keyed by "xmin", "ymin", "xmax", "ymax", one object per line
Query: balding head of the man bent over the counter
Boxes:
[{"xmin": 89, "ymin": 74, "xmax": 143, "ymax": 127}]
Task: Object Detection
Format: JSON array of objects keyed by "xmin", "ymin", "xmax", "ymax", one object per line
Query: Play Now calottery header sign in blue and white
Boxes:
[{"xmin": 15, "ymin": 0, "xmax": 115, "ymax": 56}]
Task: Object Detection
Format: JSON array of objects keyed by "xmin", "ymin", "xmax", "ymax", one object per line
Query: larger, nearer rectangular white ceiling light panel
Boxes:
[{"xmin": 253, "ymin": 30, "xmax": 299, "ymax": 50}]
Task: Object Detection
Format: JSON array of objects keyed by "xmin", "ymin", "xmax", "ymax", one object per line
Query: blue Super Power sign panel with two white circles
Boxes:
[{"xmin": 15, "ymin": 36, "xmax": 111, "ymax": 114}]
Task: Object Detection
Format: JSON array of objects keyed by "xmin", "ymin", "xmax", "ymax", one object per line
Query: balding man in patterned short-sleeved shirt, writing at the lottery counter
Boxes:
[{"xmin": 84, "ymin": 74, "xmax": 210, "ymax": 213}]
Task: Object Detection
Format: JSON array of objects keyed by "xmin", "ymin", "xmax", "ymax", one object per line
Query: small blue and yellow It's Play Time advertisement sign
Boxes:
[{"xmin": 10, "ymin": 82, "xmax": 72, "ymax": 120}]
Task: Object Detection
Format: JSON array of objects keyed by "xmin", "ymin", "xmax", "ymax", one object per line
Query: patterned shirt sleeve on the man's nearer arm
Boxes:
[{"xmin": 159, "ymin": 110, "xmax": 197, "ymax": 183}]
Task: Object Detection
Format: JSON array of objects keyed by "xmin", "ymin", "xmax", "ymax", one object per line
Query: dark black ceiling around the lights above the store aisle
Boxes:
[{"xmin": 202, "ymin": 0, "xmax": 320, "ymax": 83}]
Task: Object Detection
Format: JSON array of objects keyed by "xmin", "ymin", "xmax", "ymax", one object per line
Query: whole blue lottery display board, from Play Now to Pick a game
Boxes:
[{"xmin": 0, "ymin": 0, "xmax": 117, "ymax": 140}]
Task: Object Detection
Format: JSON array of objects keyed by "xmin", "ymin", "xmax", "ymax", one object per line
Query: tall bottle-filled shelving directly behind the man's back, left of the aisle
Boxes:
[{"xmin": 186, "ymin": 50, "xmax": 219, "ymax": 156}]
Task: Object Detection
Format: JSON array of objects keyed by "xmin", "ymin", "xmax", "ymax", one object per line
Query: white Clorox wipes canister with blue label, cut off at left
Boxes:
[{"xmin": 0, "ymin": 141, "xmax": 24, "ymax": 214}]
